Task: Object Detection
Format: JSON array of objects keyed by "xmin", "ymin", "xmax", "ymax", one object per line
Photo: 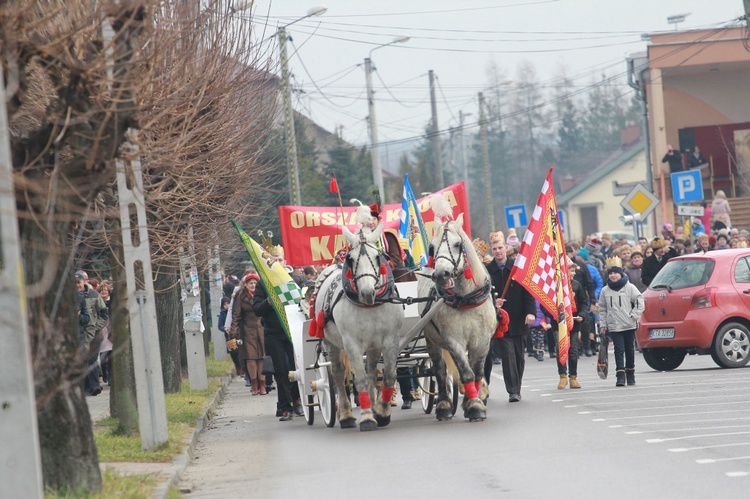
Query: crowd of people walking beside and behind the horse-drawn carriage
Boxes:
[{"xmin": 75, "ymin": 188, "xmax": 750, "ymax": 421}]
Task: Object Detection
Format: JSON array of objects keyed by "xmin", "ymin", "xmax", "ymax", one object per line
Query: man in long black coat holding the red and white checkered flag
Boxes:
[{"xmin": 484, "ymin": 232, "xmax": 536, "ymax": 402}]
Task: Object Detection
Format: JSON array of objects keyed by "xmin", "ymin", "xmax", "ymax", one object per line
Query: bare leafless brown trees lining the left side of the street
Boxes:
[{"xmin": 0, "ymin": 0, "xmax": 276, "ymax": 490}]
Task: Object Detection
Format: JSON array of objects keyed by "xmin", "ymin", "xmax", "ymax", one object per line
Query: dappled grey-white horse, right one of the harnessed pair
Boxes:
[{"xmin": 418, "ymin": 196, "xmax": 498, "ymax": 421}]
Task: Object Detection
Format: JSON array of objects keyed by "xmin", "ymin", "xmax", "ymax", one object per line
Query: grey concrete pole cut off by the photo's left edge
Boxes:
[{"xmin": 0, "ymin": 65, "xmax": 44, "ymax": 498}]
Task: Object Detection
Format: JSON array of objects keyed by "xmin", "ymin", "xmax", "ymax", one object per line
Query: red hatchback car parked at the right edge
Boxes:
[{"xmin": 636, "ymin": 248, "xmax": 750, "ymax": 371}]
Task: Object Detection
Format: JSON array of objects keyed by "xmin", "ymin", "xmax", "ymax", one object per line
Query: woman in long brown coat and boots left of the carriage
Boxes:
[{"xmin": 232, "ymin": 273, "xmax": 266, "ymax": 395}]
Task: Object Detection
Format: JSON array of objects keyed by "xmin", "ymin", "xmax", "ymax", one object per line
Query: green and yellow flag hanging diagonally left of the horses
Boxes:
[{"xmin": 231, "ymin": 220, "xmax": 302, "ymax": 340}]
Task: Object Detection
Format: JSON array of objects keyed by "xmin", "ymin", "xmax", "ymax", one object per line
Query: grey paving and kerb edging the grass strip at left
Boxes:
[{"xmin": 86, "ymin": 376, "xmax": 232, "ymax": 498}]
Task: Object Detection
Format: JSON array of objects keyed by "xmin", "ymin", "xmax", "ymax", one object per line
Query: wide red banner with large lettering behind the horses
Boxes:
[{"xmin": 279, "ymin": 182, "xmax": 471, "ymax": 267}]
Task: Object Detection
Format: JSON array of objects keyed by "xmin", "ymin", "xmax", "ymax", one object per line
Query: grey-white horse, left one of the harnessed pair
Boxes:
[{"xmin": 315, "ymin": 211, "xmax": 404, "ymax": 431}]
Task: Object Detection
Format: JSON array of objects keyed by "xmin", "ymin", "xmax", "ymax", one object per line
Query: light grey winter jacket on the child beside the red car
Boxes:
[{"xmin": 599, "ymin": 274, "xmax": 646, "ymax": 333}]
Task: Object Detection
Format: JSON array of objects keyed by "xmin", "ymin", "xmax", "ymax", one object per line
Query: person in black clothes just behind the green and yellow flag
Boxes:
[{"xmin": 253, "ymin": 281, "xmax": 302, "ymax": 421}]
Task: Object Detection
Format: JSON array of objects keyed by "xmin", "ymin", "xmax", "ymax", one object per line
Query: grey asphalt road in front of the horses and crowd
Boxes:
[{"xmin": 180, "ymin": 354, "xmax": 750, "ymax": 499}]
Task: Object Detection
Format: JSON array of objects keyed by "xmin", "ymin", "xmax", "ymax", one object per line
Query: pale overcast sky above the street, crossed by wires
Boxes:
[{"xmin": 245, "ymin": 0, "xmax": 743, "ymax": 154}]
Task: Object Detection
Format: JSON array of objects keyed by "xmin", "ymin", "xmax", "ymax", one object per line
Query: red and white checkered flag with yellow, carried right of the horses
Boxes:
[{"xmin": 510, "ymin": 168, "xmax": 573, "ymax": 364}]
